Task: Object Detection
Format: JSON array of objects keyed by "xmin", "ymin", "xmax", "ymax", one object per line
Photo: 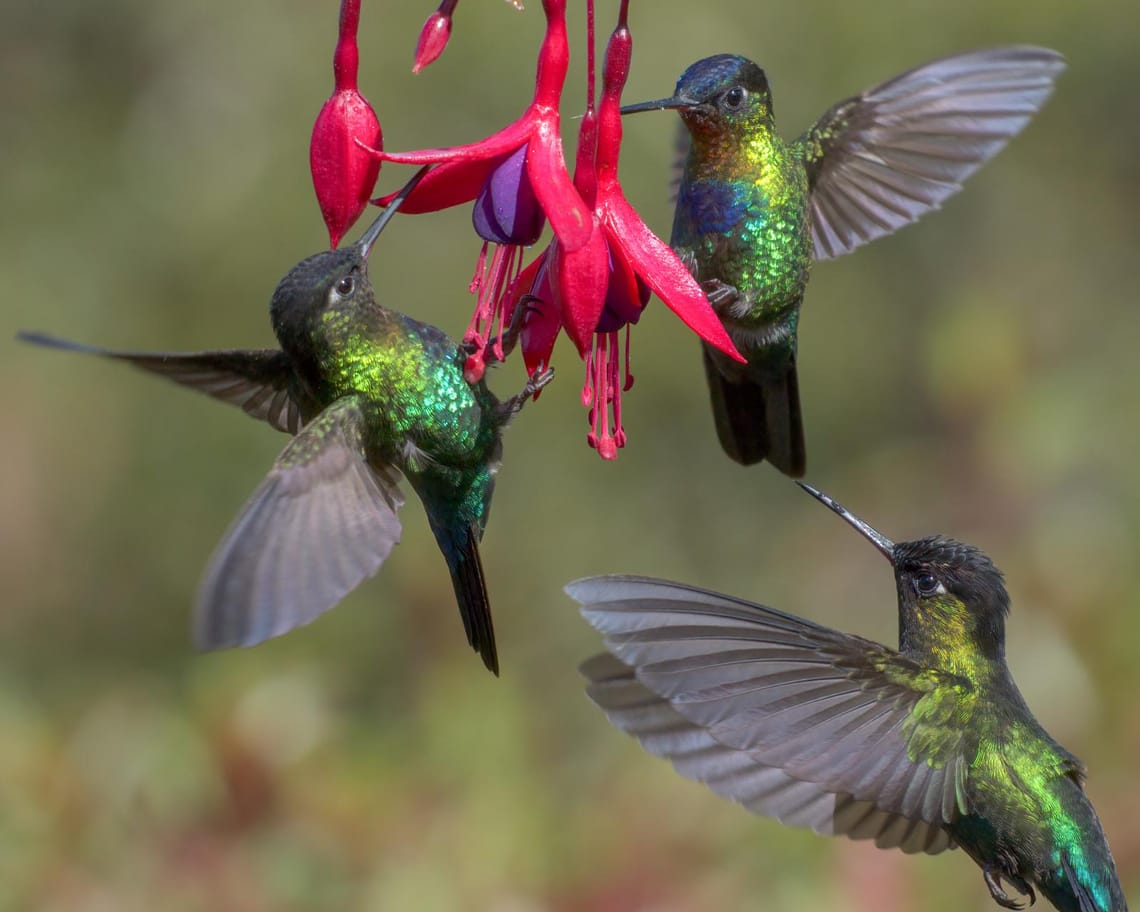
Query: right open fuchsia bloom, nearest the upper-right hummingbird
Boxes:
[{"xmin": 520, "ymin": 0, "xmax": 743, "ymax": 459}]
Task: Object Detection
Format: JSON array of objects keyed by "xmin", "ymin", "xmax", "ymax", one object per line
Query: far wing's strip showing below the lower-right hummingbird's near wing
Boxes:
[{"xmin": 579, "ymin": 652, "xmax": 954, "ymax": 855}]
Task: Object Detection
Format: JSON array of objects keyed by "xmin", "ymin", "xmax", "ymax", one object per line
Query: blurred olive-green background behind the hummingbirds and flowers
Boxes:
[{"xmin": 0, "ymin": 0, "xmax": 1140, "ymax": 912}]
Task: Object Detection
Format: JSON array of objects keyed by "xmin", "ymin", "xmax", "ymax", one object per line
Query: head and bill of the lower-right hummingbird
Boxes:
[{"xmin": 796, "ymin": 481, "xmax": 1009, "ymax": 666}]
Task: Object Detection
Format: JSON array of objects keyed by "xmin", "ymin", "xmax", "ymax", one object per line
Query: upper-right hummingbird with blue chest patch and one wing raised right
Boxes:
[{"xmin": 621, "ymin": 47, "xmax": 1065, "ymax": 478}]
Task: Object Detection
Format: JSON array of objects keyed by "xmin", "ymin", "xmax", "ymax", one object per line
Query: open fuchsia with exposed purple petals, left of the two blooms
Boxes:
[{"xmin": 373, "ymin": 0, "xmax": 593, "ymax": 382}]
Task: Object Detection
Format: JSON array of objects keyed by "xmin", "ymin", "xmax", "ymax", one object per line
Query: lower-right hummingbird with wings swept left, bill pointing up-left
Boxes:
[{"xmin": 567, "ymin": 485, "xmax": 1127, "ymax": 912}]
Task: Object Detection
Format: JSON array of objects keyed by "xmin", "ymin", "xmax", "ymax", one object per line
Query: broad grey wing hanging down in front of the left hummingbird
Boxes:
[{"xmin": 195, "ymin": 396, "xmax": 404, "ymax": 650}]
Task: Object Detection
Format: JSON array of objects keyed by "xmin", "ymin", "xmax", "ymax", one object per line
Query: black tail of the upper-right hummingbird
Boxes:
[{"xmin": 705, "ymin": 345, "xmax": 807, "ymax": 478}]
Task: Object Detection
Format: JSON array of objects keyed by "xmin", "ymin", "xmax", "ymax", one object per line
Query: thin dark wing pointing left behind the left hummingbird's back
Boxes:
[{"xmin": 17, "ymin": 332, "xmax": 319, "ymax": 434}]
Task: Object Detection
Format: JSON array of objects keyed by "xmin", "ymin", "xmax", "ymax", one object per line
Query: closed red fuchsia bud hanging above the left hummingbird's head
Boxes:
[{"xmin": 309, "ymin": 0, "xmax": 384, "ymax": 247}]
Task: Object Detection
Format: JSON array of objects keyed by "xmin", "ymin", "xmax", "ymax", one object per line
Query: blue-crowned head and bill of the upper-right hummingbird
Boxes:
[{"xmin": 621, "ymin": 54, "xmax": 772, "ymax": 136}]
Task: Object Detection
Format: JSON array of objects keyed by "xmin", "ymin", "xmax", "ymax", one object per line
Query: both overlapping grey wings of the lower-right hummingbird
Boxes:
[{"xmin": 567, "ymin": 577, "xmax": 974, "ymax": 850}]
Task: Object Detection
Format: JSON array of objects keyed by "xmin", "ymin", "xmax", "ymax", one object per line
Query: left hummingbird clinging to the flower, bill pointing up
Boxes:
[{"xmin": 19, "ymin": 167, "xmax": 553, "ymax": 675}]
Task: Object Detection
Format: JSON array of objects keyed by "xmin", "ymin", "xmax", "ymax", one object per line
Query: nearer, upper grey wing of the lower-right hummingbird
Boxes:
[{"xmin": 567, "ymin": 577, "xmax": 976, "ymax": 838}]
